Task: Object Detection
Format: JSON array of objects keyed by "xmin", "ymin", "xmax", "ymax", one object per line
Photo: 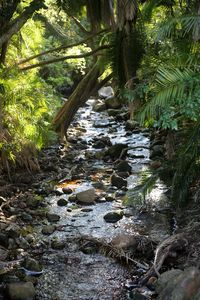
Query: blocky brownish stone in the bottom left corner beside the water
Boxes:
[{"xmin": 6, "ymin": 282, "xmax": 35, "ymax": 300}]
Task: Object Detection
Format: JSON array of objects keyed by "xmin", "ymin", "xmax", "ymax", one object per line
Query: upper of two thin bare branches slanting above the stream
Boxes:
[{"xmin": 17, "ymin": 29, "xmax": 107, "ymax": 65}]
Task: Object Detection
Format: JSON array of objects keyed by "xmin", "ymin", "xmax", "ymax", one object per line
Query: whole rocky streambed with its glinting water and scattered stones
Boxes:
[{"xmin": 0, "ymin": 94, "xmax": 200, "ymax": 300}]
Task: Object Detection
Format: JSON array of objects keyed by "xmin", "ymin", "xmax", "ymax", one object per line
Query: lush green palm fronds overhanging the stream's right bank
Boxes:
[{"xmin": 126, "ymin": 1, "xmax": 200, "ymax": 205}]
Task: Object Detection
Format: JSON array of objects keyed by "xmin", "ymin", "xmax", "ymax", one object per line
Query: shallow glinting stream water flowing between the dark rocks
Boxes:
[{"xmin": 37, "ymin": 100, "xmax": 170, "ymax": 300}]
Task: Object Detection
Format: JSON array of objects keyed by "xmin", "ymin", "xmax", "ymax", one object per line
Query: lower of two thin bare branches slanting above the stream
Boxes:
[{"xmin": 20, "ymin": 45, "xmax": 111, "ymax": 71}]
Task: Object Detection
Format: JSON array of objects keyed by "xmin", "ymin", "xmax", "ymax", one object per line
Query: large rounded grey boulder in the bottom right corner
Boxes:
[{"xmin": 156, "ymin": 267, "xmax": 200, "ymax": 300}]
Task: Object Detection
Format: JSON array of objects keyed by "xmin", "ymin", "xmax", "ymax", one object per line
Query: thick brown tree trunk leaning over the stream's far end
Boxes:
[{"xmin": 53, "ymin": 60, "xmax": 110, "ymax": 139}]
